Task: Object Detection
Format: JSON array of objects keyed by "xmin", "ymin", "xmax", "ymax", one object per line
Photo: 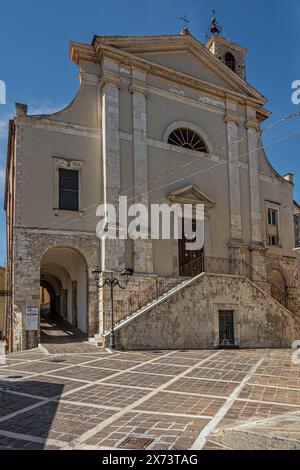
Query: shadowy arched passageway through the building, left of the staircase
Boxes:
[{"xmin": 40, "ymin": 247, "xmax": 88, "ymax": 334}]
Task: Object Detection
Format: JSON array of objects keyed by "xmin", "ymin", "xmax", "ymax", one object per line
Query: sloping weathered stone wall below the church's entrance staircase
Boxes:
[{"xmin": 116, "ymin": 275, "xmax": 300, "ymax": 350}]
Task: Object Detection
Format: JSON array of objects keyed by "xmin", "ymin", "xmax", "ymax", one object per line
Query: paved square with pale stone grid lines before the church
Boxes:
[{"xmin": 0, "ymin": 343, "xmax": 300, "ymax": 450}]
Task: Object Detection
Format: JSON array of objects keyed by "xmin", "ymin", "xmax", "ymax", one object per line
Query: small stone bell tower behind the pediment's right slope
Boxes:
[{"xmin": 206, "ymin": 10, "xmax": 247, "ymax": 80}]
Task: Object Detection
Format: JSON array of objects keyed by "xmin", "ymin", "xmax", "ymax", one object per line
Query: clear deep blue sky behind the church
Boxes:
[{"xmin": 0, "ymin": 0, "xmax": 300, "ymax": 264}]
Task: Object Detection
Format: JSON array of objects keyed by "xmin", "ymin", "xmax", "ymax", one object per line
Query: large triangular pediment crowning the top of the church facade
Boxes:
[{"xmin": 94, "ymin": 34, "xmax": 266, "ymax": 104}]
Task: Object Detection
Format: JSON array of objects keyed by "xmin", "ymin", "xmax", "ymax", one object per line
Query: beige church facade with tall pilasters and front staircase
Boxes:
[{"xmin": 6, "ymin": 30, "xmax": 300, "ymax": 350}]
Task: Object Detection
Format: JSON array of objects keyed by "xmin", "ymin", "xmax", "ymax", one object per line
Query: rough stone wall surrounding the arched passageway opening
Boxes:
[{"xmin": 13, "ymin": 230, "xmax": 101, "ymax": 349}]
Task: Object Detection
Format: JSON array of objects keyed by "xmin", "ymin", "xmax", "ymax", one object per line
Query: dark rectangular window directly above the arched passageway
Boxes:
[{"xmin": 59, "ymin": 168, "xmax": 79, "ymax": 211}]
